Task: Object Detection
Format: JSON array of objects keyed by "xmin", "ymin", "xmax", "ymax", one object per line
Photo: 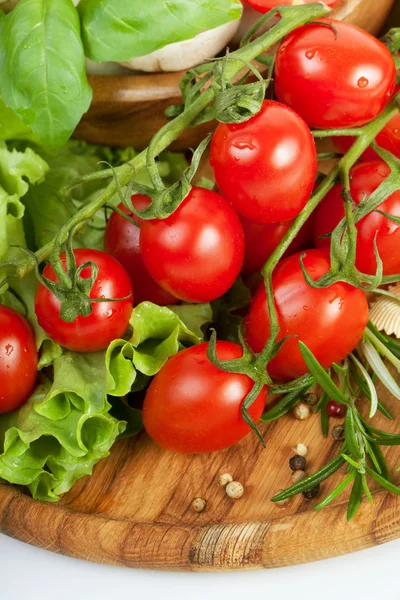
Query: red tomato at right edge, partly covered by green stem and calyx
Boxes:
[{"xmin": 314, "ymin": 160, "xmax": 400, "ymax": 275}]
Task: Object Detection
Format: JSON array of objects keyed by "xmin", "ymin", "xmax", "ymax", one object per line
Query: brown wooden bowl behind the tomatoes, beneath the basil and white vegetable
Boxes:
[{"xmin": 74, "ymin": 0, "xmax": 395, "ymax": 150}]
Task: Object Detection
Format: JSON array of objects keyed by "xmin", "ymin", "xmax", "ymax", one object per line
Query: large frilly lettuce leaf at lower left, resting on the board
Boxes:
[{"xmin": 0, "ymin": 364, "xmax": 125, "ymax": 502}]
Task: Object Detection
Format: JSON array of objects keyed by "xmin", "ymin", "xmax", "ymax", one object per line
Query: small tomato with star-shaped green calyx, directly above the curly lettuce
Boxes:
[{"xmin": 35, "ymin": 248, "xmax": 133, "ymax": 352}]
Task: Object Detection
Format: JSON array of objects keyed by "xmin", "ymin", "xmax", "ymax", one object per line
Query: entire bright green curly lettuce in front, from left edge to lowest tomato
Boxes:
[{"xmin": 0, "ymin": 302, "xmax": 211, "ymax": 502}]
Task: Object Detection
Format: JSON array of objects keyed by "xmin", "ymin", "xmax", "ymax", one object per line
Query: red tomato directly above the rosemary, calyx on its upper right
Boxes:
[{"xmin": 245, "ymin": 250, "xmax": 368, "ymax": 380}]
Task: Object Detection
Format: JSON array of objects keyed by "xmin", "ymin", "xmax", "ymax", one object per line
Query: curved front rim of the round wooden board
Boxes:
[{"xmin": 0, "ymin": 485, "xmax": 400, "ymax": 571}]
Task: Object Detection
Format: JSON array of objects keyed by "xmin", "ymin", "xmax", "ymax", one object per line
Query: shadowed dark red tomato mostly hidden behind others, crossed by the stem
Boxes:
[{"xmin": 240, "ymin": 217, "xmax": 313, "ymax": 275}]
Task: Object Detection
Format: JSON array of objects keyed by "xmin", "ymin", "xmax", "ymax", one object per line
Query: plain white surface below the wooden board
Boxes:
[{"xmin": 0, "ymin": 532, "xmax": 400, "ymax": 600}]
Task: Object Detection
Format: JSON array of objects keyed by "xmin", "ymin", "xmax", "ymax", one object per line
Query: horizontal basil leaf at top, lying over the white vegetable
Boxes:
[{"xmin": 78, "ymin": 0, "xmax": 242, "ymax": 62}]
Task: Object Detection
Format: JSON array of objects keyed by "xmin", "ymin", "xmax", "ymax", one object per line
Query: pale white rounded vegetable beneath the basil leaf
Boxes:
[{"xmin": 121, "ymin": 19, "xmax": 240, "ymax": 73}]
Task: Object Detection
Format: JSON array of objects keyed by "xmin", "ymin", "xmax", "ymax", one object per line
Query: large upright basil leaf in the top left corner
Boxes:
[{"xmin": 0, "ymin": 0, "xmax": 92, "ymax": 149}]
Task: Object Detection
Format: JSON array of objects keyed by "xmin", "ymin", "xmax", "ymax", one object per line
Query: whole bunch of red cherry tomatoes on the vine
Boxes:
[{"xmin": 0, "ymin": 17, "xmax": 400, "ymax": 452}]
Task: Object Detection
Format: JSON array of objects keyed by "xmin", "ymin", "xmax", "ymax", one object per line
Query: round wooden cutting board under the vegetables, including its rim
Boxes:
[{"xmin": 0, "ymin": 376, "xmax": 400, "ymax": 571}]
